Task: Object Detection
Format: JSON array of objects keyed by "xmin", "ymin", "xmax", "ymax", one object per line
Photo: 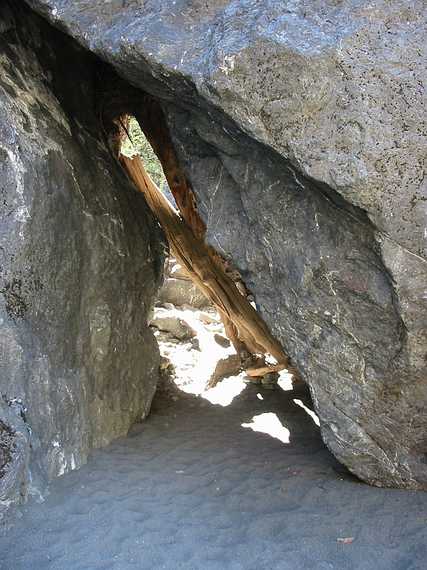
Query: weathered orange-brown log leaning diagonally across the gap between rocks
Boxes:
[{"xmin": 120, "ymin": 151, "xmax": 290, "ymax": 373}]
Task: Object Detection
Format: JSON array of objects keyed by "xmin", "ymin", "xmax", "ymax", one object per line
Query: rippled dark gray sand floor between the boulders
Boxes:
[{"xmin": 0, "ymin": 385, "xmax": 427, "ymax": 570}]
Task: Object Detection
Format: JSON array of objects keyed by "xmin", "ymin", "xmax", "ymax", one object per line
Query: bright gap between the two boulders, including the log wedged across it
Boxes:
[{"xmin": 115, "ymin": 110, "xmax": 308, "ymax": 404}]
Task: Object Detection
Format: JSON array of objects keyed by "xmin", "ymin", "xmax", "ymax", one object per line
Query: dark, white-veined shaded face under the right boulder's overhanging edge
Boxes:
[{"xmin": 167, "ymin": 106, "xmax": 412, "ymax": 485}]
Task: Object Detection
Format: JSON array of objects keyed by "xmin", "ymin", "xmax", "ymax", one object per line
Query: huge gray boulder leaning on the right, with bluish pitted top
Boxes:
[{"xmin": 21, "ymin": 0, "xmax": 427, "ymax": 488}]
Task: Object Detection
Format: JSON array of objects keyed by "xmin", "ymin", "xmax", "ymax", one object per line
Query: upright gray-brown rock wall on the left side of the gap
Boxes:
[{"xmin": 0, "ymin": 2, "xmax": 163, "ymax": 501}]
